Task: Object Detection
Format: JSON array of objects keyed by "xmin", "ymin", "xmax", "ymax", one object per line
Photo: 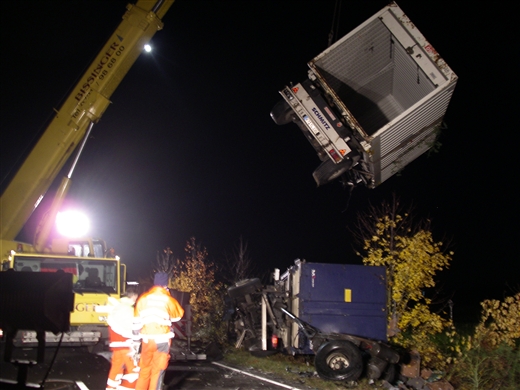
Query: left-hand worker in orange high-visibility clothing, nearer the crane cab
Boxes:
[{"xmin": 106, "ymin": 286, "xmax": 139, "ymax": 390}]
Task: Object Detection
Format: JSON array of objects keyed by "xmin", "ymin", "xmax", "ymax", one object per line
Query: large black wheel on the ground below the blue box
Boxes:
[{"xmin": 314, "ymin": 340, "xmax": 363, "ymax": 381}]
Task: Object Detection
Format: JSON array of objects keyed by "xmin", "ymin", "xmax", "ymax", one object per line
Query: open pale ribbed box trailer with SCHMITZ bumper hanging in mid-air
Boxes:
[{"xmin": 280, "ymin": 3, "xmax": 457, "ymax": 187}]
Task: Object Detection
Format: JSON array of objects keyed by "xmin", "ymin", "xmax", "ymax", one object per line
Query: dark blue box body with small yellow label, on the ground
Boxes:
[{"xmin": 281, "ymin": 262, "xmax": 387, "ymax": 341}]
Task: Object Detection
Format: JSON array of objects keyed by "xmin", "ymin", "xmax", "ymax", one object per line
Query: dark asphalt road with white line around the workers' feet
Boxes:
[{"xmin": 0, "ymin": 342, "xmax": 309, "ymax": 390}]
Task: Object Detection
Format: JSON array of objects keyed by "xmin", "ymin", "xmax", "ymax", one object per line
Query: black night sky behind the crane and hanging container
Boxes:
[{"xmin": 0, "ymin": 0, "xmax": 520, "ymax": 322}]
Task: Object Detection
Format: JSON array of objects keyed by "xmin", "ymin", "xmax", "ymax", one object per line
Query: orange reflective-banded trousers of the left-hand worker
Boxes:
[{"xmin": 106, "ymin": 348, "xmax": 139, "ymax": 390}]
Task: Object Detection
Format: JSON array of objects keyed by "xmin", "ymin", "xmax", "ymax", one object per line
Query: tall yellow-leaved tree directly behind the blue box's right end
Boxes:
[{"xmin": 358, "ymin": 198, "xmax": 453, "ymax": 365}]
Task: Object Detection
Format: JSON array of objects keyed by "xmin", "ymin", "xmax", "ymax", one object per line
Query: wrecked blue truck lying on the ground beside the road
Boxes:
[{"xmin": 228, "ymin": 260, "xmax": 415, "ymax": 382}]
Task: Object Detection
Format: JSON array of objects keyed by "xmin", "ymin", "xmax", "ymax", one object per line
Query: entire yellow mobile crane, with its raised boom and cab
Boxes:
[{"xmin": 0, "ymin": 0, "xmax": 174, "ymax": 350}]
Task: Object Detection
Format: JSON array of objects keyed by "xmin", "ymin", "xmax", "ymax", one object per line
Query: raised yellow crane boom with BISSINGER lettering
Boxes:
[{"xmin": 0, "ymin": 0, "xmax": 174, "ymax": 248}]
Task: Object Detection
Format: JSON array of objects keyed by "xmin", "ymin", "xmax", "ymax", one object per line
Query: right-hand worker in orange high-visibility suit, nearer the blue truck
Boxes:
[{"xmin": 134, "ymin": 272, "xmax": 184, "ymax": 390}]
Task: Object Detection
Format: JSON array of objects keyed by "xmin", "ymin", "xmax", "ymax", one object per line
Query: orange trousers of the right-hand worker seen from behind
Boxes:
[{"xmin": 135, "ymin": 339, "xmax": 171, "ymax": 390}]
